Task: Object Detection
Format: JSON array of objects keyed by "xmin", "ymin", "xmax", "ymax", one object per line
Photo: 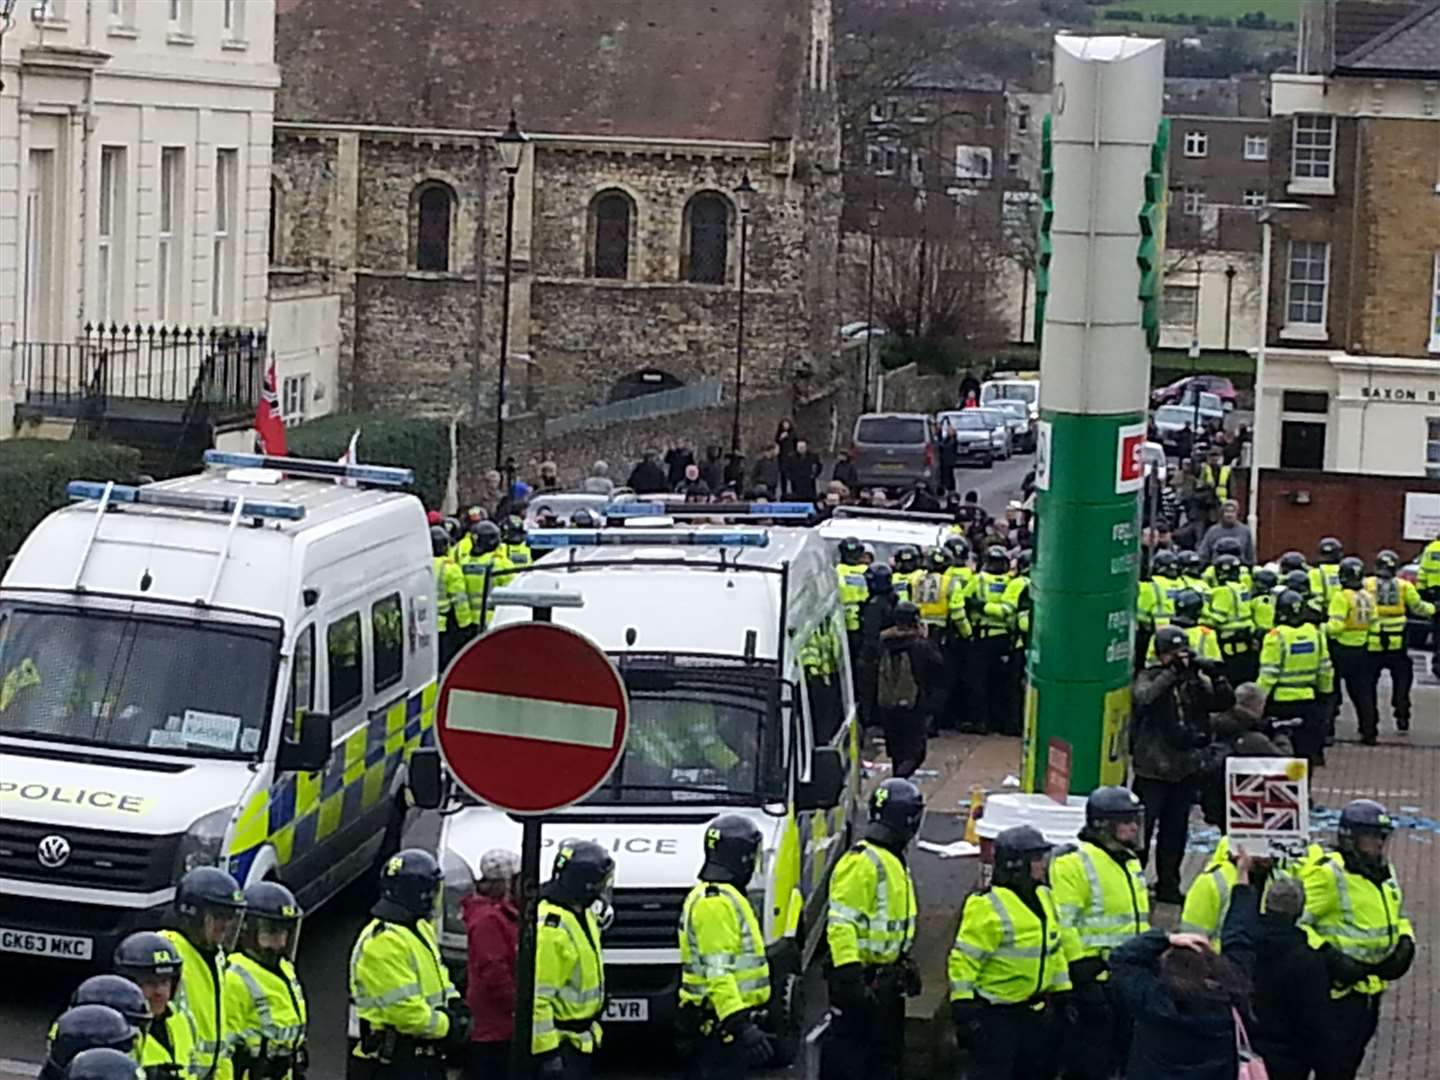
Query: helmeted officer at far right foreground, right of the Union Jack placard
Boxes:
[{"xmin": 1300, "ymin": 799, "xmax": 1416, "ymax": 1080}]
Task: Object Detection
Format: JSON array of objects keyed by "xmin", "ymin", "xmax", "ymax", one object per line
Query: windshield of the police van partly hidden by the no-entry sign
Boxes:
[{"xmin": 589, "ymin": 654, "xmax": 785, "ymax": 805}]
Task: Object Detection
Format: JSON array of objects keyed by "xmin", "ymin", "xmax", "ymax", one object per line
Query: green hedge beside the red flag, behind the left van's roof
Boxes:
[{"xmin": 285, "ymin": 413, "xmax": 451, "ymax": 508}]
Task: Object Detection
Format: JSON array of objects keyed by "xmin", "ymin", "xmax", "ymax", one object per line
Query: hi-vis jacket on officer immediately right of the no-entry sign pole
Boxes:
[{"xmin": 541, "ymin": 900, "xmax": 605, "ymax": 1054}]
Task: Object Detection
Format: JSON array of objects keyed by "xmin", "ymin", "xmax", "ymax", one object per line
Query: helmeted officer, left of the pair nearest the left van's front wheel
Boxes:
[{"xmin": 160, "ymin": 867, "xmax": 245, "ymax": 1080}]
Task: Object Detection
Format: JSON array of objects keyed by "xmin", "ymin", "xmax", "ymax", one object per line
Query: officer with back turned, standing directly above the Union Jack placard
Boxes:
[{"xmin": 1256, "ymin": 589, "xmax": 1335, "ymax": 765}]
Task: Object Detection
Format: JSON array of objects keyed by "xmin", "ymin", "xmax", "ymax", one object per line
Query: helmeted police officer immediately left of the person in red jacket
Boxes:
[{"xmin": 346, "ymin": 852, "xmax": 463, "ymax": 1080}]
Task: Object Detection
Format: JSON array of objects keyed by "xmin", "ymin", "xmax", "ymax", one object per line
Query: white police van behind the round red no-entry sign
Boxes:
[{"xmin": 420, "ymin": 504, "xmax": 860, "ymax": 1060}]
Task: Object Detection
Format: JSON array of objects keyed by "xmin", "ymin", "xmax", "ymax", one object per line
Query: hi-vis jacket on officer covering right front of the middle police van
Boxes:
[{"xmin": 680, "ymin": 881, "xmax": 770, "ymax": 1020}]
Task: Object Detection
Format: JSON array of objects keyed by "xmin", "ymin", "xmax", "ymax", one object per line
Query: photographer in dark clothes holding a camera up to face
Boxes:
[{"xmin": 1130, "ymin": 626, "xmax": 1236, "ymax": 904}]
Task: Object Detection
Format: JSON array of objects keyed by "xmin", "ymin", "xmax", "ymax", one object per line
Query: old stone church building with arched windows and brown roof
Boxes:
[{"xmin": 271, "ymin": 0, "xmax": 841, "ymax": 432}]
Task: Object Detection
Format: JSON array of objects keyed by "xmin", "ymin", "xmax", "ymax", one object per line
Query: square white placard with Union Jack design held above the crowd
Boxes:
[{"xmin": 1225, "ymin": 757, "xmax": 1310, "ymax": 857}]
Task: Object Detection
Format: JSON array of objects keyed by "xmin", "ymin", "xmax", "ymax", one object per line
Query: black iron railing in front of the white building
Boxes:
[{"xmin": 17, "ymin": 324, "xmax": 268, "ymax": 412}]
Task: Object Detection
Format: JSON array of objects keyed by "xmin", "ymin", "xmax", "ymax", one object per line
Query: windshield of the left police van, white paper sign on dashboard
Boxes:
[{"xmin": 0, "ymin": 603, "xmax": 279, "ymax": 759}]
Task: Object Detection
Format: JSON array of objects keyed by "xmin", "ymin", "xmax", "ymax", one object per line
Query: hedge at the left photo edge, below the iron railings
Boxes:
[{"xmin": 0, "ymin": 439, "xmax": 140, "ymax": 562}]
